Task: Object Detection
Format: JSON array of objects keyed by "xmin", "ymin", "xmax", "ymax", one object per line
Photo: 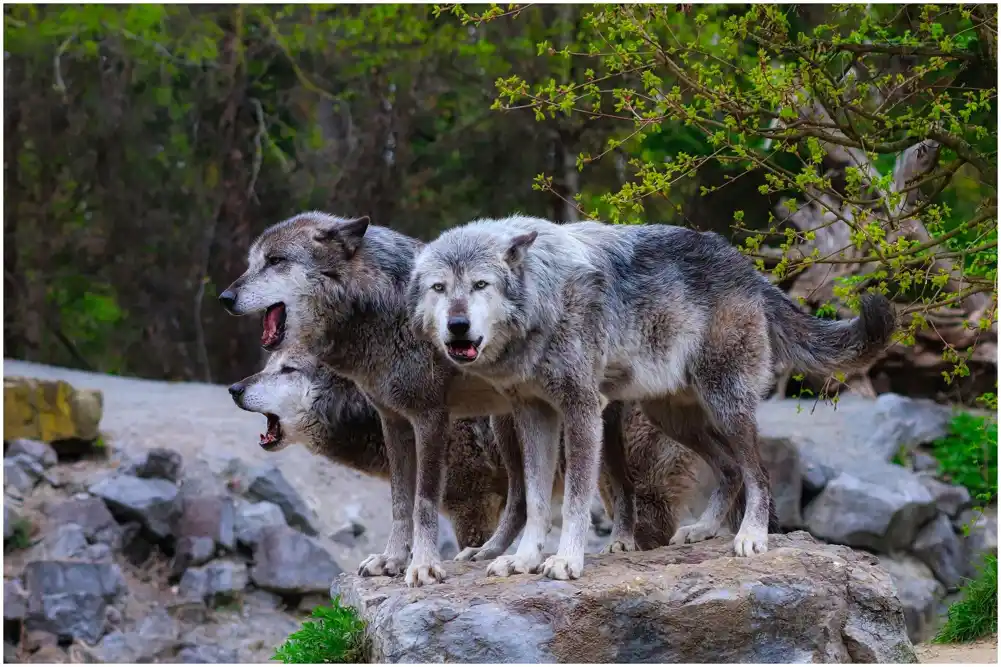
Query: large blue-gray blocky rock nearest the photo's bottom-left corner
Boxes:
[{"xmin": 24, "ymin": 561, "xmax": 126, "ymax": 644}]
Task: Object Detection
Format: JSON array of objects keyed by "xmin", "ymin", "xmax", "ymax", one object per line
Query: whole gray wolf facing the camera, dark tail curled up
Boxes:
[{"xmin": 408, "ymin": 216, "xmax": 895, "ymax": 578}]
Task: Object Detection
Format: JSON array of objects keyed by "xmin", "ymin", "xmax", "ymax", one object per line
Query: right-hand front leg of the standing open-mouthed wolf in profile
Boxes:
[{"xmin": 405, "ymin": 410, "xmax": 450, "ymax": 588}]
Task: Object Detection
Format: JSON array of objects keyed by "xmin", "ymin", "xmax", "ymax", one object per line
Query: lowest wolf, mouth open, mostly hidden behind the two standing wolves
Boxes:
[{"xmin": 230, "ymin": 345, "xmax": 697, "ymax": 548}]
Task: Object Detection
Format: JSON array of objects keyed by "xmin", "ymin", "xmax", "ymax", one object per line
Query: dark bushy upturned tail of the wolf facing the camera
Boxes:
[{"xmin": 766, "ymin": 284, "xmax": 897, "ymax": 374}]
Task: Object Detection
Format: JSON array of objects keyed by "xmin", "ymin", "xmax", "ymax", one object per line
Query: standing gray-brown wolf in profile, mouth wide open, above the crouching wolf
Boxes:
[{"xmin": 219, "ymin": 212, "xmax": 635, "ymax": 586}]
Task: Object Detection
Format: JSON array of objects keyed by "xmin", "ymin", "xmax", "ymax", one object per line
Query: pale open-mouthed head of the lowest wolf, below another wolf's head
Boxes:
[{"xmin": 229, "ymin": 347, "xmax": 319, "ymax": 452}]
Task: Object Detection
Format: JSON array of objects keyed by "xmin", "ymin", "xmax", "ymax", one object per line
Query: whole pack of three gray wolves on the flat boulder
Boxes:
[{"xmin": 219, "ymin": 211, "xmax": 896, "ymax": 587}]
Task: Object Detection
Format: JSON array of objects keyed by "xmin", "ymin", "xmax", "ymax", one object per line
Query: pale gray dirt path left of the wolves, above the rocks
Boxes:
[{"xmin": 3, "ymin": 360, "xmax": 391, "ymax": 569}]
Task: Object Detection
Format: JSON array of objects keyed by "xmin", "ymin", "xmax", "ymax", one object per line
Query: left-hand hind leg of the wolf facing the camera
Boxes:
[{"xmin": 642, "ymin": 397, "xmax": 741, "ymax": 545}]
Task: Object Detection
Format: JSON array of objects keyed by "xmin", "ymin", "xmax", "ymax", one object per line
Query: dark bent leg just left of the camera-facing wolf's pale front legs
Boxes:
[{"xmin": 455, "ymin": 415, "xmax": 526, "ymax": 561}]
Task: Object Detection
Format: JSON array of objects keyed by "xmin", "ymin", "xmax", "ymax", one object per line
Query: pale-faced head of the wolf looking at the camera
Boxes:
[{"xmin": 408, "ymin": 223, "xmax": 538, "ymax": 367}]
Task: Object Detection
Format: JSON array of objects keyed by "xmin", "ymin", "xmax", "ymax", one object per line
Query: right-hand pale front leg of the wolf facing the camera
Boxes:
[{"xmin": 543, "ymin": 388, "xmax": 602, "ymax": 579}]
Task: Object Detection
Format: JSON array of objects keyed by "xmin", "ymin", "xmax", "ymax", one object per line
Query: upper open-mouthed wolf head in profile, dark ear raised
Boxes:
[{"xmin": 219, "ymin": 211, "xmax": 368, "ymax": 351}]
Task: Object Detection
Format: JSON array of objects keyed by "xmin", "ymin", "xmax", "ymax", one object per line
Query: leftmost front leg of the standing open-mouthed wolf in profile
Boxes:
[{"xmin": 358, "ymin": 411, "xmax": 417, "ymax": 577}]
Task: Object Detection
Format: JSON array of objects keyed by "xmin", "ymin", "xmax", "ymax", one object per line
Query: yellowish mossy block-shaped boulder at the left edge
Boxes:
[{"xmin": 3, "ymin": 378, "xmax": 104, "ymax": 443}]
